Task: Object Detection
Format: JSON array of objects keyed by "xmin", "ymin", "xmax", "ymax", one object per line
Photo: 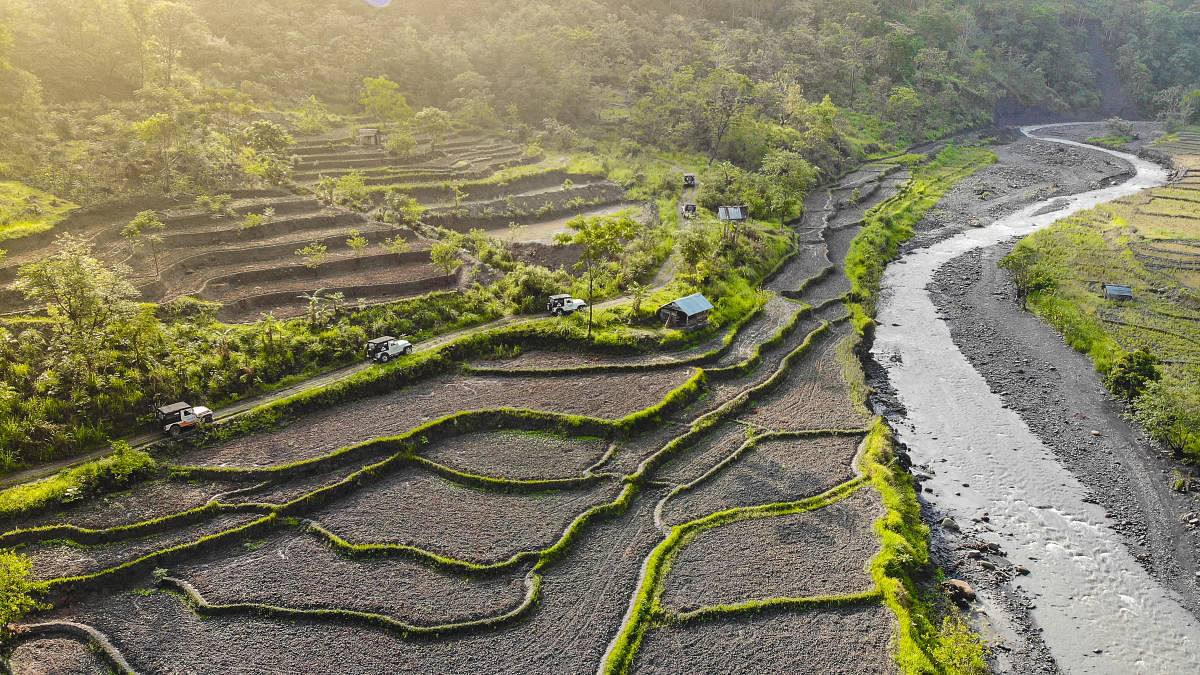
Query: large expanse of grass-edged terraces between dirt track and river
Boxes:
[{"xmin": 7, "ymin": 162, "xmax": 895, "ymax": 673}]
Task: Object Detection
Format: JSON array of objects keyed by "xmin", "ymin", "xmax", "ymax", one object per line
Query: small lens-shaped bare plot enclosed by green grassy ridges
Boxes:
[{"xmin": 421, "ymin": 431, "xmax": 610, "ymax": 479}]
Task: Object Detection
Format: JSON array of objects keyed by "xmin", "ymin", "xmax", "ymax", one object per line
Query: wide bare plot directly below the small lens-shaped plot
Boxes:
[{"xmin": 312, "ymin": 471, "xmax": 620, "ymax": 563}]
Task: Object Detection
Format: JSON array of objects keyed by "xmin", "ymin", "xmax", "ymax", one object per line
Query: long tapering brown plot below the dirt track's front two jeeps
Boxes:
[{"xmin": 176, "ymin": 368, "xmax": 694, "ymax": 466}]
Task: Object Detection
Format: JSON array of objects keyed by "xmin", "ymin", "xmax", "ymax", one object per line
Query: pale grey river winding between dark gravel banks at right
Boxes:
[{"xmin": 872, "ymin": 125, "xmax": 1200, "ymax": 674}]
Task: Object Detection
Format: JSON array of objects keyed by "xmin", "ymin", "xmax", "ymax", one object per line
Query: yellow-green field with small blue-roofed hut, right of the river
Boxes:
[{"xmin": 1002, "ymin": 159, "xmax": 1200, "ymax": 461}]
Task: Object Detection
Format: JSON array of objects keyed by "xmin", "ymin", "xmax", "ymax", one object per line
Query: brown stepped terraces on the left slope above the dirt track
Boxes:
[{"xmin": 0, "ymin": 131, "xmax": 631, "ymax": 323}]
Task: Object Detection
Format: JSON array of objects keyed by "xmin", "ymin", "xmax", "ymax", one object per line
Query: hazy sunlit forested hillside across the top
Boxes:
[{"xmin": 0, "ymin": 0, "xmax": 1200, "ymax": 203}]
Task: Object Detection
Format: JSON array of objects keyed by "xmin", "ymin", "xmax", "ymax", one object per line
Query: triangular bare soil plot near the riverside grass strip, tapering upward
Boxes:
[{"xmin": 739, "ymin": 322, "xmax": 869, "ymax": 431}]
